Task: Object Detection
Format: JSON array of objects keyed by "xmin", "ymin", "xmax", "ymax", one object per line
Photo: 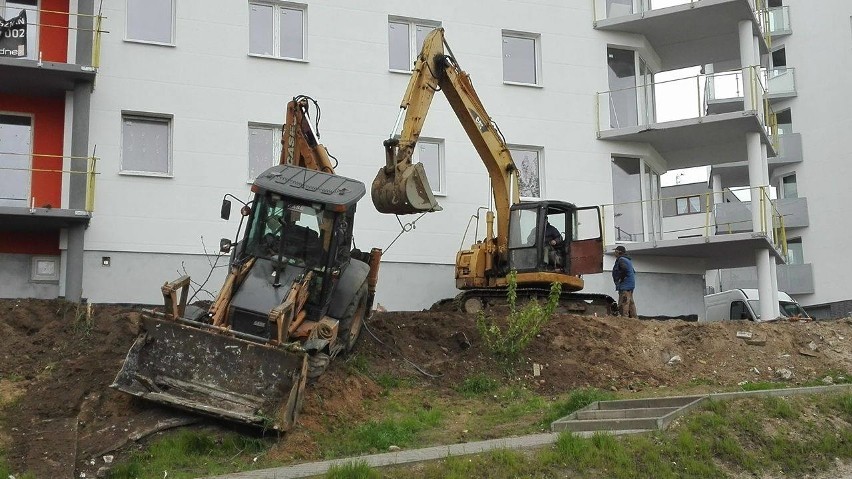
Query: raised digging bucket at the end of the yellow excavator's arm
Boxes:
[{"xmin": 372, "ymin": 163, "xmax": 442, "ymax": 215}]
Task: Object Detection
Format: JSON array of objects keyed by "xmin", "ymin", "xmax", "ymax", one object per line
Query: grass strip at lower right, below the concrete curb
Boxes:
[{"xmin": 382, "ymin": 393, "xmax": 852, "ymax": 479}]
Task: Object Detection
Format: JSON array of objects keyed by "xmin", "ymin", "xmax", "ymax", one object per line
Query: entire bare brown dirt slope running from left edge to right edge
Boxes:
[{"xmin": 0, "ymin": 300, "xmax": 852, "ymax": 477}]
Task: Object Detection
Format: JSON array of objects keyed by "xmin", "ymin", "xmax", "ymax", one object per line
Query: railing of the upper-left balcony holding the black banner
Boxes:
[{"xmin": 3, "ymin": 7, "xmax": 109, "ymax": 69}]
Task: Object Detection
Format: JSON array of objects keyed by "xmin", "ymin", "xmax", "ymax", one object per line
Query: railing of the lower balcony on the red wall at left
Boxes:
[{"xmin": 0, "ymin": 152, "xmax": 100, "ymax": 213}]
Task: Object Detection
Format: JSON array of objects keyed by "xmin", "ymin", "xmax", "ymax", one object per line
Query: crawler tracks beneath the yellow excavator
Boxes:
[{"xmin": 453, "ymin": 288, "xmax": 618, "ymax": 316}]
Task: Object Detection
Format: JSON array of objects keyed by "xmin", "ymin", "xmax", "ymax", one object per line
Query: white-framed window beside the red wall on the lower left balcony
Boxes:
[{"xmin": 0, "ymin": 114, "xmax": 31, "ymax": 207}]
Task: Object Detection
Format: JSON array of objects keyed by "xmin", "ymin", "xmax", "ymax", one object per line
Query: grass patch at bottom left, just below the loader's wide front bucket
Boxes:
[{"xmin": 109, "ymin": 429, "xmax": 268, "ymax": 479}]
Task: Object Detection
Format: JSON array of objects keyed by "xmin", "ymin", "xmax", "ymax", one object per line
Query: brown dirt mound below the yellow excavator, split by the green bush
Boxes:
[{"xmin": 362, "ymin": 311, "xmax": 852, "ymax": 394}]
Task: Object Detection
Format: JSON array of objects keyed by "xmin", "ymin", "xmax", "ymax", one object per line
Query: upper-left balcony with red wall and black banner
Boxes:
[{"xmin": 0, "ymin": 8, "xmax": 106, "ymax": 96}]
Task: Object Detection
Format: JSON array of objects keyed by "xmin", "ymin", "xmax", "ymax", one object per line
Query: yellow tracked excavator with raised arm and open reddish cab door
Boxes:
[{"xmin": 371, "ymin": 28, "xmax": 616, "ymax": 315}]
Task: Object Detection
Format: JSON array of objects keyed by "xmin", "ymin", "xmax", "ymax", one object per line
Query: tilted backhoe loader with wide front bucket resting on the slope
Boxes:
[{"xmin": 111, "ymin": 96, "xmax": 382, "ymax": 431}]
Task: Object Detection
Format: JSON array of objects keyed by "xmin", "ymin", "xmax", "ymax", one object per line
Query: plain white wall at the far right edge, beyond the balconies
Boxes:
[{"xmin": 773, "ymin": 0, "xmax": 852, "ymax": 305}]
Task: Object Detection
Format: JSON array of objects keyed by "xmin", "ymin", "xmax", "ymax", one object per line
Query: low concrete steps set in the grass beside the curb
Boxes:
[{"xmin": 550, "ymin": 396, "xmax": 707, "ymax": 432}]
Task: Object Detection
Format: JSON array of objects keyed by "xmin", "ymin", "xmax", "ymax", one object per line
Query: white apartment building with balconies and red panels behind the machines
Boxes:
[{"xmin": 5, "ymin": 0, "xmax": 852, "ymax": 316}]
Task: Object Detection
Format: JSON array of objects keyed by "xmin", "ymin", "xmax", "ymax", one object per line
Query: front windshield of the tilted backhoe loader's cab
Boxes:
[{"xmin": 246, "ymin": 194, "xmax": 331, "ymax": 269}]
